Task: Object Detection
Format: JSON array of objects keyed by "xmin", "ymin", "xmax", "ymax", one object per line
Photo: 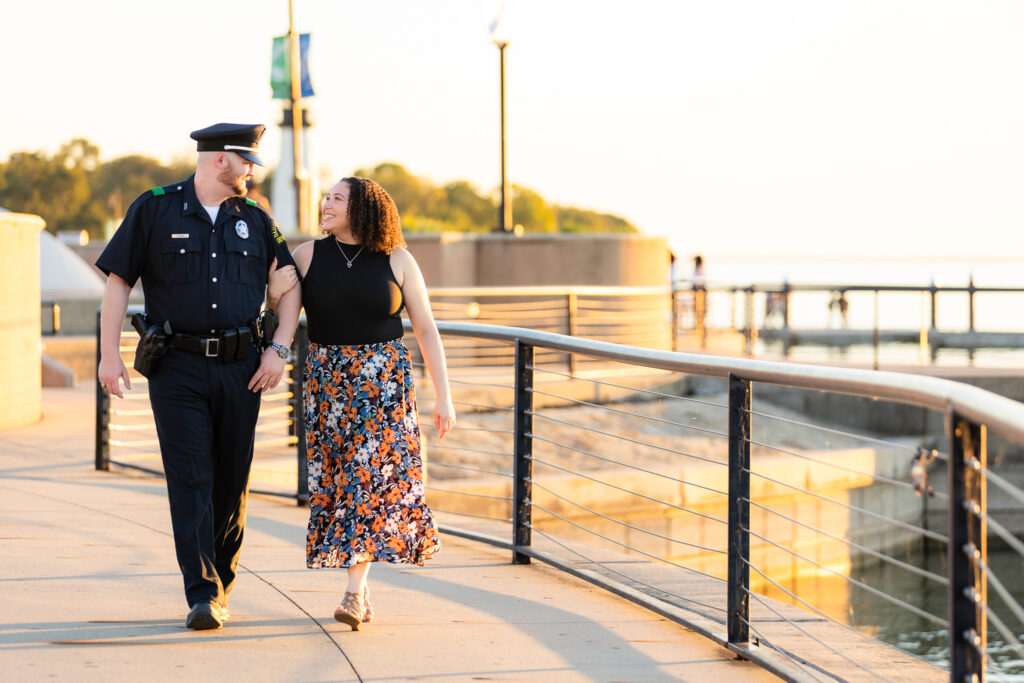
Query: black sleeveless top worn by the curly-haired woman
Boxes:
[{"xmin": 302, "ymin": 240, "xmax": 406, "ymax": 345}]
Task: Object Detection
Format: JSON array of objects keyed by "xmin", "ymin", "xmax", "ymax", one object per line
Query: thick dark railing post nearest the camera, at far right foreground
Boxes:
[{"xmin": 946, "ymin": 410, "xmax": 988, "ymax": 681}]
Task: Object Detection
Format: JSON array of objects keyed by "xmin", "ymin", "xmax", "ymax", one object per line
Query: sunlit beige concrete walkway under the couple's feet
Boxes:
[{"xmin": 0, "ymin": 383, "xmax": 774, "ymax": 681}]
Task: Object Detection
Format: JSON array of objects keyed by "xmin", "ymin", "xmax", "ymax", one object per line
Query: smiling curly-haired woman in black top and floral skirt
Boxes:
[{"xmin": 267, "ymin": 178, "xmax": 455, "ymax": 631}]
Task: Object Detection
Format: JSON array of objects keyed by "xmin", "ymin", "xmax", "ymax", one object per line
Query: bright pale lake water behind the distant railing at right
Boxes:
[{"xmin": 692, "ymin": 259, "xmax": 1024, "ymax": 368}]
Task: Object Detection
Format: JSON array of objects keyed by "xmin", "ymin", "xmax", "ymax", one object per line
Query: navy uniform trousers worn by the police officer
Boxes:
[{"xmin": 150, "ymin": 346, "xmax": 260, "ymax": 607}]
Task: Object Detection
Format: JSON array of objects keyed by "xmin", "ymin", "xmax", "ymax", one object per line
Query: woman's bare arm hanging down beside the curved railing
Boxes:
[{"xmin": 391, "ymin": 247, "xmax": 455, "ymax": 438}]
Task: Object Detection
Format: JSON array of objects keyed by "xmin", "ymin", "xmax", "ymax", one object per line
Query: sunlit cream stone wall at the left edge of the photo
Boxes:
[{"xmin": 0, "ymin": 213, "xmax": 45, "ymax": 429}]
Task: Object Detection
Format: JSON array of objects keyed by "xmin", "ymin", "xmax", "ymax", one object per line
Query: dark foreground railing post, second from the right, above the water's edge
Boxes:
[{"xmin": 726, "ymin": 373, "xmax": 751, "ymax": 643}]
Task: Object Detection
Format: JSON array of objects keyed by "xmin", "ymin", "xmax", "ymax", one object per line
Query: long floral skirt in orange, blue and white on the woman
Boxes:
[{"xmin": 303, "ymin": 339, "xmax": 440, "ymax": 568}]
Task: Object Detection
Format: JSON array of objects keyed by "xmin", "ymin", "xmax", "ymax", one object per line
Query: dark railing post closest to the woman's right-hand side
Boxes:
[{"xmin": 512, "ymin": 339, "xmax": 534, "ymax": 564}]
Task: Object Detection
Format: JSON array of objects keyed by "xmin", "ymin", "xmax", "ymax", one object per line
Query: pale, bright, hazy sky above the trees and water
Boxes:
[{"xmin": 0, "ymin": 0, "xmax": 1024, "ymax": 262}]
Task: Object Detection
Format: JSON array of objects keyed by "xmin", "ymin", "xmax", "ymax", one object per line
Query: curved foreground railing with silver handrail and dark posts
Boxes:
[{"xmin": 96, "ymin": 318, "xmax": 1024, "ymax": 681}]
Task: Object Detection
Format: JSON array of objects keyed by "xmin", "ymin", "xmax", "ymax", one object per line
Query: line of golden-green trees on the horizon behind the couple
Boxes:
[{"xmin": 0, "ymin": 138, "xmax": 637, "ymax": 237}]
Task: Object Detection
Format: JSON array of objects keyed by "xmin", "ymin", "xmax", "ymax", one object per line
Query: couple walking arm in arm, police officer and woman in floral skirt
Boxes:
[{"xmin": 96, "ymin": 124, "xmax": 455, "ymax": 630}]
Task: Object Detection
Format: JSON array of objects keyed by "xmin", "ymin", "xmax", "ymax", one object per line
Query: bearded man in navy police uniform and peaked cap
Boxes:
[{"xmin": 96, "ymin": 124, "xmax": 301, "ymax": 629}]
